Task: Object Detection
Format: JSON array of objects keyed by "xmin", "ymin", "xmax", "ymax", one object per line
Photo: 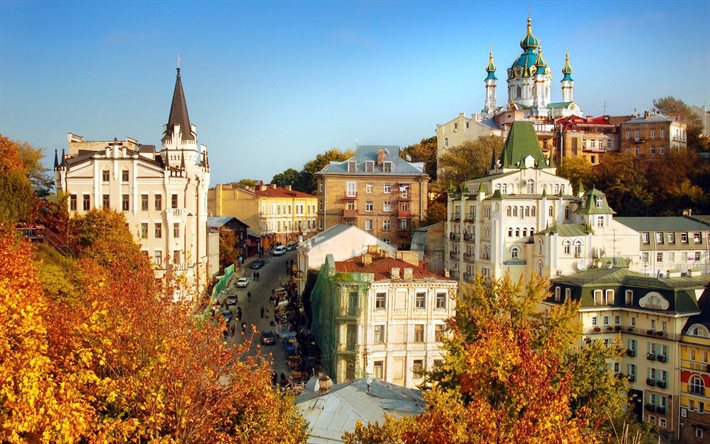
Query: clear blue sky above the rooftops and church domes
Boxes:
[{"xmin": 0, "ymin": 0, "xmax": 710, "ymax": 184}]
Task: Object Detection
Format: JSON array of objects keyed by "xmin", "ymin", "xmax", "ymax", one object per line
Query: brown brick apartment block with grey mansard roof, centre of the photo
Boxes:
[{"xmin": 317, "ymin": 145, "xmax": 429, "ymax": 248}]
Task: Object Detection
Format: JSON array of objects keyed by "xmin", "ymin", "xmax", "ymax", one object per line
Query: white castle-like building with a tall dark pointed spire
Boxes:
[{"xmin": 54, "ymin": 68, "xmax": 210, "ymax": 297}]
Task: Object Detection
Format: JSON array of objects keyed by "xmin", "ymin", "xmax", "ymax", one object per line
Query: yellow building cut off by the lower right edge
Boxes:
[{"xmin": 676, "ymin": 290, "xmax": 710, "ymax": 443}]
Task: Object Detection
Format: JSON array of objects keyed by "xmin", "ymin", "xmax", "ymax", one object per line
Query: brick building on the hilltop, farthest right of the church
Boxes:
[{"xmin": 619, "ymin": 111, "xmax": 688, "ymax": 156}]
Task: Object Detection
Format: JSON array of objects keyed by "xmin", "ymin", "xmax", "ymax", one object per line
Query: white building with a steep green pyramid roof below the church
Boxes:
[{"xmin": 445, "ymin": 121, "xmax": 639, "ymax": 281}]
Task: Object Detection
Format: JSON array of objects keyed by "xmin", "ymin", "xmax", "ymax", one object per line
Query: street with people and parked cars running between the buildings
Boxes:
[{"xmin": 220, "ymin": 251, "xmax": 296, "ymax": 377}]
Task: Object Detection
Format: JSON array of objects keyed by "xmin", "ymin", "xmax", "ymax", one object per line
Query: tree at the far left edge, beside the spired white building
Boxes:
[{"xmin": 0, "ymin": 135, "xmax": 34, "ymax": 224}]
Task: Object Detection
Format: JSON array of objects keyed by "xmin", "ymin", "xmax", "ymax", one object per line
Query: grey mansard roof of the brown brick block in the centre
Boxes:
[{"xmin": 318, "ymin": 145, "xmax": 427, "ymax": 176}]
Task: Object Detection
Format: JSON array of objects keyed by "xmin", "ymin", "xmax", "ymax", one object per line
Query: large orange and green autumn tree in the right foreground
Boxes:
[{"xmin": 344, "ymin": 276, "xmax": 625, "ymax": 443}]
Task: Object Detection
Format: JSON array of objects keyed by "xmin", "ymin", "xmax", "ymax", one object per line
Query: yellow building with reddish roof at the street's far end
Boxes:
[{"xmin": 207, "ymin": 184, "xmax": 318, "ymax": 249}]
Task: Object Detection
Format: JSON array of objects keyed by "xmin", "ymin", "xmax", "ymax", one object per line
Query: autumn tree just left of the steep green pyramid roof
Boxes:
[{"xmin": 438, "ymin": 136, "xmax": 505, "ymax": 187}]
